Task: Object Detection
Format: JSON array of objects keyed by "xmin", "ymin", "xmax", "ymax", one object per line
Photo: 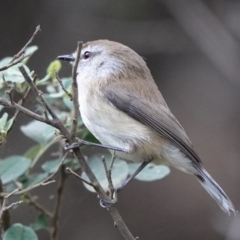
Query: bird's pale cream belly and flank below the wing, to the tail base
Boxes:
[{"xmin": 80, "ymin": 91, "xmax": 195, "ymax": 173}]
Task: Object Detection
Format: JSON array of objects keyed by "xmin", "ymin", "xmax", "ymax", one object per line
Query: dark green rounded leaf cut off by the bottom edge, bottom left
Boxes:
[{"xmin": 3, "ymin": 223, "xmax": 38, "ymax": 240}]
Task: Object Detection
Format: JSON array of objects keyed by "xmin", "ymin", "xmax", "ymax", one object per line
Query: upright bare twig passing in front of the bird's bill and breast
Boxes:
[{"xmin": 70, "ymin": 42, "xmax": 82, "ymax": 141}]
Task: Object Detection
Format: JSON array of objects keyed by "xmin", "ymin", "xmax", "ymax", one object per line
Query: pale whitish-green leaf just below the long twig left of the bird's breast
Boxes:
[{"xmin": 20, "ymin": 120, "xmax": 55, "ymax": 143}]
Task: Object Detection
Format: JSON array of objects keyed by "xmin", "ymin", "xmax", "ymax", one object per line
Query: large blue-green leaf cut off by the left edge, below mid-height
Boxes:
[{"xmin": 0, "ymin": 155, "xmax": 31, "ymax": 184}]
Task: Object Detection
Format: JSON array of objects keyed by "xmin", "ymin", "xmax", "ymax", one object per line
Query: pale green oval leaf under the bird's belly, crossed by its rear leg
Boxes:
[{"xmin": 128, "ymin": 163, "xmax": 170, "ymax": 182}]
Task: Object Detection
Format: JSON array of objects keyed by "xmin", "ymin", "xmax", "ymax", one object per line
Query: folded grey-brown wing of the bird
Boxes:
[{"xmin": 102, "ymin": 87, "xmax": 201, "ymax": 165}]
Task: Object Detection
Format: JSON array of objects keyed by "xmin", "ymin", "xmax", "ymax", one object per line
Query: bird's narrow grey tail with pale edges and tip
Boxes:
[{"xmin": 195, "ymin": 168, "xmax": 236, "ymax": 215}]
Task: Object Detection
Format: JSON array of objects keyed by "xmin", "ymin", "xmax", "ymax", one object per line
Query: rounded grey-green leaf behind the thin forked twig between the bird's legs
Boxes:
[{"xmin": 82, "ymin": 154, "xmax": 128, "ymax": 192}]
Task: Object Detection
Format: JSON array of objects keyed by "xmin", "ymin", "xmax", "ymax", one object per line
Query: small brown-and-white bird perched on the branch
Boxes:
[{"xmin": 58, "ymin": 40, "xmax": 236, "ymax": 215}]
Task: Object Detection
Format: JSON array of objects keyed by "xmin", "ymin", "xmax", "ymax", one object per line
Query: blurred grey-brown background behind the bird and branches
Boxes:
[{"xmin": 0, "ymin": 0, "xmax": 240, "ymax": 240}]
